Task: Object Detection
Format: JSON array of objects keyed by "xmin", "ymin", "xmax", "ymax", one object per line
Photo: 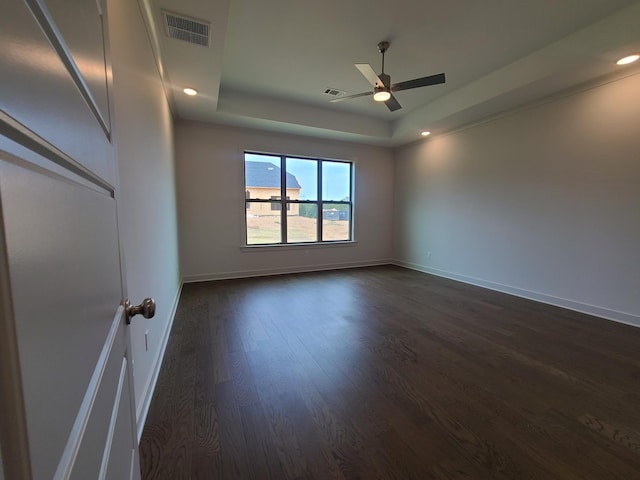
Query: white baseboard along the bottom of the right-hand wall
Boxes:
[{"xmin": 392, "ymin": 260, "xmax": 640, "ymax": 327}]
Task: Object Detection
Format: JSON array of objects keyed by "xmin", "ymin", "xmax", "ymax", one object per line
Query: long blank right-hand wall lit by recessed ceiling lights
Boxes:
[{"xmin": 394, "ymin": 75, "xmax": 640, "ymax": 325}]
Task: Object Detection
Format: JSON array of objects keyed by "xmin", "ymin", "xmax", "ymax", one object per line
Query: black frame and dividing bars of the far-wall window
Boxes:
[{"xmin": 243, "ymin": 150, "xmax": 356, "ymax": 248}]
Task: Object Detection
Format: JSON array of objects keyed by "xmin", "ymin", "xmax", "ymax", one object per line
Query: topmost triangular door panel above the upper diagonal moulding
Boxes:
[{"xmin": 45, "ymin": 0, "xmax": 109, "ymax": 130}]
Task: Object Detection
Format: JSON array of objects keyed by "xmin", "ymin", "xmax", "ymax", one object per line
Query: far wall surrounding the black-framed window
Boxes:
[{"xmin": 176, "ymin": 122, "xmax": 393, "ymax": 281}]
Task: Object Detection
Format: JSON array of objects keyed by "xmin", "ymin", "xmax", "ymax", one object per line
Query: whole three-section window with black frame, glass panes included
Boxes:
[{"xmin": 244, "ymin": 152, "xmax": 353, "ymax": 245}]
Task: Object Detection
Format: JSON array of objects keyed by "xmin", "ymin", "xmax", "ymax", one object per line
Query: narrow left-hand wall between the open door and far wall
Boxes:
[{"xmin": 108, "ymin": 0, "xmax": 180, "ymax": 431}]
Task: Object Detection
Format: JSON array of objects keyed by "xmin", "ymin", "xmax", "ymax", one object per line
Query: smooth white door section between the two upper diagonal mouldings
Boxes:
[{"xmin": 0, "ymin": 0, "xmax": 115, "ymax": 184}]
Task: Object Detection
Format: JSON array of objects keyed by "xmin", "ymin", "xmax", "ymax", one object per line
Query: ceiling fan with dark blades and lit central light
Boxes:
[{"xmin": 331, "ymin": 42, "xmax": 445, "ymax": 112}]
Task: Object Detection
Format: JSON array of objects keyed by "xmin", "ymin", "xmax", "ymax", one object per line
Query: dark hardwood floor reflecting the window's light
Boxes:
[{"xmin": 140, "ymin": 267, "xmax": 640, "ymax": 480}]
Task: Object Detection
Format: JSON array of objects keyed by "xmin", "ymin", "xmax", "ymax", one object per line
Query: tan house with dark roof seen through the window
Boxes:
[{"xmin": 244, "ymin": 161, "xmax": 302, "ymax": 215}]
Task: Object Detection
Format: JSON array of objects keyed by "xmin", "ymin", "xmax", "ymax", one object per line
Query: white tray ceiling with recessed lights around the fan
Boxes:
[{"xmin": 143, "ymin": 0, "xmax": 640, "ymax": 146}]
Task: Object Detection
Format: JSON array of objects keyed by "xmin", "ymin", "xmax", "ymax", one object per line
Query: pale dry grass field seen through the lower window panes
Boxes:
[{"xmin": 247, "ymin": 215, "xmax": 349, "ymax": 245}]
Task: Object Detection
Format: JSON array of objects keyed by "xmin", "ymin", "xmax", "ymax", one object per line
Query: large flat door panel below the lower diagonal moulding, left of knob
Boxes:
[{"xmin": 0, "ymin": 151, "xmax": 124, "ymax": 478}]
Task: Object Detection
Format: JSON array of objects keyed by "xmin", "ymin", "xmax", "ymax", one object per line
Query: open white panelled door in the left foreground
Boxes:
[{"xmin": 0, "ymin": 0, "xmax": 139, "ymax": 480}]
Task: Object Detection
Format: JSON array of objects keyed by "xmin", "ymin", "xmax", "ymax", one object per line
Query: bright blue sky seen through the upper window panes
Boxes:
[{"xmin": 245, "ymin": 153, "xmax": 350, "ymax": 201}]
